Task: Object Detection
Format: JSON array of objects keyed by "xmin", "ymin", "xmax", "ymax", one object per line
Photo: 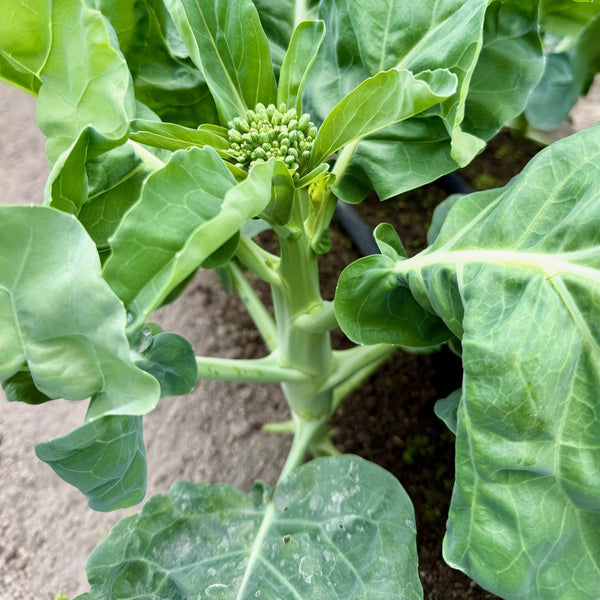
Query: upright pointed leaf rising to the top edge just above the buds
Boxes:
[{"xmin": 165, "ymin": 0, "xmax": 277, "ymax": 124}]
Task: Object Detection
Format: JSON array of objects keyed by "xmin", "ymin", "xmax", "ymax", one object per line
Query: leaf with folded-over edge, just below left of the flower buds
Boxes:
[{"xmin": 103, "ymin": 147, "xmax": 273, "ymax": 321}]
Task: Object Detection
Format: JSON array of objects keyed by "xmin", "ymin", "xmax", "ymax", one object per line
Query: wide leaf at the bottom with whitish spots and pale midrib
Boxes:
[{"xmin": 79, "ymin": 456, "xmax": 423, "ymax": 600}]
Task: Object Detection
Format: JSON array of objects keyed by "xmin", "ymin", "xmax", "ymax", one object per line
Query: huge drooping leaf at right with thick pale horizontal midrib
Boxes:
[{"xmin": 338, "ymin": 126, "xmax": 600, "ymax": 600}]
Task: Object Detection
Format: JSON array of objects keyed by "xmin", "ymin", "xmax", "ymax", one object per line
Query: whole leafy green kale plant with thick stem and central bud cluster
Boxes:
[{"xmin": 0, "ymin": 0, "xmax": 600, "ymax": 600}]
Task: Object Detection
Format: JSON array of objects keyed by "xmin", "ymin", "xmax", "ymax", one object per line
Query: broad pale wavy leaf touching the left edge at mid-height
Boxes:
[{"xmin": 0, "ymin": 206, "xmax": 159, "ymax": 416}]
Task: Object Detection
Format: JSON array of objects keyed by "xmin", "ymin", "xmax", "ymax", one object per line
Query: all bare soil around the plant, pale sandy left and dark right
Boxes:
[{"xmin": 0, "ymin": 76, "xmax": 600, "ymax": 600}]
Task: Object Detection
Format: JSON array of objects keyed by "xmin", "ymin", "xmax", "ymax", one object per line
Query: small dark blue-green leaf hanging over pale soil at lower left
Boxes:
[{"xmin": 35, "ymin": 416, "xmax": 146, "ymax": 511}]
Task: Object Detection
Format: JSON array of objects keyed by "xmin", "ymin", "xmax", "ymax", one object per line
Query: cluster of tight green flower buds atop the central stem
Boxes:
[{"xmin": 228, "ymin": 103, "xmax": 317, "ymax": 173}]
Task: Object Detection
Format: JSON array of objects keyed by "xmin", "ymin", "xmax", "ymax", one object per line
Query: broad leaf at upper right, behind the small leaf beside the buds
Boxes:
[{"xmin": 307, "ymin": 0, "xmax": 543, "ymax": 202}]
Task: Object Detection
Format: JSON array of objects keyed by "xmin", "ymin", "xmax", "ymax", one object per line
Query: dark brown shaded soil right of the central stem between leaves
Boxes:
[{"xmin": 322, "ymin": 133, "xmax": 540, "ymax": 600}]
